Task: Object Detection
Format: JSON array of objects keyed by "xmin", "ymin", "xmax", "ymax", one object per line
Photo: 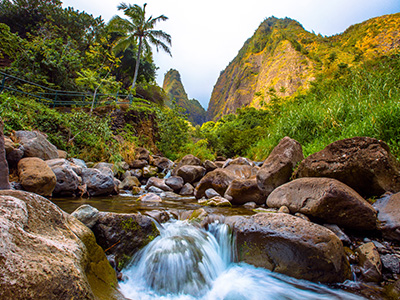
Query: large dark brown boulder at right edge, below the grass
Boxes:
[{"xmin": 296, "ymin": 137, "xmax": 400, "ymax": 197}]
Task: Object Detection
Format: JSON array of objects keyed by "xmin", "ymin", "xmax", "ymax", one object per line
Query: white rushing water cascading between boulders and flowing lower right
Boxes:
[{"xmin": 120, "ymin": 221, "xmax": 363, "ymax": 300}]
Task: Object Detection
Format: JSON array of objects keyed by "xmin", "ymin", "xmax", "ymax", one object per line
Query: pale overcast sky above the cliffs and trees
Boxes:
[{"xmin": 63, "ymin": 0, "xmax": 400, "ymax": 109}]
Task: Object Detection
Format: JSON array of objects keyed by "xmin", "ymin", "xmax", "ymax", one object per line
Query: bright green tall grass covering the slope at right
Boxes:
[{"xmin": 247, "ymin": 55, "xmax": 400, "ymax": 160}]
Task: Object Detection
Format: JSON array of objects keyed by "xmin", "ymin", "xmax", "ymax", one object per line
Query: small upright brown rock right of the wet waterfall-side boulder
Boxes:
[{"xmin": 356, "ymin": 242, "xmax": 382, "ymax": 282}]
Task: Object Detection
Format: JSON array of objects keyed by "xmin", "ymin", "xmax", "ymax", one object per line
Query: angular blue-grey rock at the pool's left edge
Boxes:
[{"xmin": 82, "ymin": 168, "xmax": 114, "ymax": 196}]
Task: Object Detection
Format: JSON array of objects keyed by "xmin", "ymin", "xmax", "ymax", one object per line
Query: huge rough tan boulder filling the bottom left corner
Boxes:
[{"xmin": 0, "ymin": 190, "xmax": 124, "ymax": 300}]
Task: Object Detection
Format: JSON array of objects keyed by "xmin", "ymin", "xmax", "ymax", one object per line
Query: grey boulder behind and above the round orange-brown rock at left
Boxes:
[{"xmin": 14, "ymin": 130, "xmax": 58, "ymax": 160}]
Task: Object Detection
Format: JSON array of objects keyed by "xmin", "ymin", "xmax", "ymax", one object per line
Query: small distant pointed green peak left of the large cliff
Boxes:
[{"xmin": 163, "ymin": 69, "xmax": 206, "ymax": 125}]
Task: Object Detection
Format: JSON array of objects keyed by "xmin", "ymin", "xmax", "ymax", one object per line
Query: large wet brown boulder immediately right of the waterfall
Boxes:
[{"xmin": 225, "ymin": 213, "xmax": 350, "ymax": 283}]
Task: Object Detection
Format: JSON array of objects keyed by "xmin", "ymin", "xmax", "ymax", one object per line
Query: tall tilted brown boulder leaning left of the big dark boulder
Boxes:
[{"xmin": 257, "ymin": 137, "xmax": 304, "ymax": 196}]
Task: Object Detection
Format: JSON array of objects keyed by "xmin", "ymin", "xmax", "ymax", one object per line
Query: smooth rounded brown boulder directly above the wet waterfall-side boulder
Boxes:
[{"xmin": 267, "ymin": 178, "xmax": 376, "ymax": 230}]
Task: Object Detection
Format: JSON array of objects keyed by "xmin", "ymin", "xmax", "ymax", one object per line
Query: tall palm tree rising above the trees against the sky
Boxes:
[{"xmin": 110, "ymin": 3, "xmax": 172, "ymax": 91}]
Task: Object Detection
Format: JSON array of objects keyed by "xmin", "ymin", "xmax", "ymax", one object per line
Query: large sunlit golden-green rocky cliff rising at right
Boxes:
[{"xmin": 207, "ymin": 13, "xmax": 400, "ymax": 120}]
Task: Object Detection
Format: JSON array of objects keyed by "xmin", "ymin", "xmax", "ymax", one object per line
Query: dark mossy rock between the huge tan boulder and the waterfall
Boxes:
[{"xmin": 92, "ymin": 212, "xmax": 160, "ymax": 270}]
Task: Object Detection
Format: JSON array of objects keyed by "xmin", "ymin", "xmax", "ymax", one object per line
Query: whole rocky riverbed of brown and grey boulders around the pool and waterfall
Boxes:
[{"xmin": 0, "ymin": 132, "xmax": 400, "ymax": 299}]
